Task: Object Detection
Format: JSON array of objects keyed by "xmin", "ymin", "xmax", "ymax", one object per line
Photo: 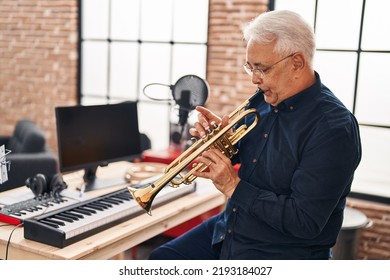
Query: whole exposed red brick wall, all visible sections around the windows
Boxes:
[{"xmin": 0, "ymin": 0, "xmax": 390, "ymax": 259}]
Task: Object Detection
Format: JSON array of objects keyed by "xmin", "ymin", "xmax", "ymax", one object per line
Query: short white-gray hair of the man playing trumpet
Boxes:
[{"xmin": 243, "ymin": 10, "xmax": 316, "ymax": 66}]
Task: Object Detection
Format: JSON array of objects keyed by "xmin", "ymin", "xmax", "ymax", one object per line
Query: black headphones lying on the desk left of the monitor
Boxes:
[{"xmin": 26, "ymin": 173, "xmax": 68, "ymax": 197}]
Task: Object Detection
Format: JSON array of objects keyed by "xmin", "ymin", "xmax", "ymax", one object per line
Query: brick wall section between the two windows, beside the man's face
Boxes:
[{"xmin": 206, "ymin": 0, "xmax": 268, "ymax": 114}]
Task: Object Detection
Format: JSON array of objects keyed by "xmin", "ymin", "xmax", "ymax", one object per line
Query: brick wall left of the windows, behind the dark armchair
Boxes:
[{"xmin": 0, "ymin": 0, "xmax": 78, "ymax": 154}]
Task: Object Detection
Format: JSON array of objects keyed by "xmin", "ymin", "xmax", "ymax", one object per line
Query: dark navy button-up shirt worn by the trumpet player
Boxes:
[{"xmin": 213, "ymin": 73, "xmax": 361, "ymax": 259}]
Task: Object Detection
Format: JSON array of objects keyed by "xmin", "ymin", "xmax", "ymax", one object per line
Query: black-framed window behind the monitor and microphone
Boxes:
[{"xmin": 79, "ymin": 0, "xmax": 209, "ymax": 149}]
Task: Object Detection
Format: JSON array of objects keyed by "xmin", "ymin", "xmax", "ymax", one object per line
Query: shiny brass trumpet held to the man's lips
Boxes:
[{"xmin": 127, "ymin": 90, "xmax": 260, "ymax": 215}]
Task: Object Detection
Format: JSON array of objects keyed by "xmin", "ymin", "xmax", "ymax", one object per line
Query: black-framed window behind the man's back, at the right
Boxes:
[{"xmin": 275, "ymin": 0, "xmax": 390, "ymax": 197}]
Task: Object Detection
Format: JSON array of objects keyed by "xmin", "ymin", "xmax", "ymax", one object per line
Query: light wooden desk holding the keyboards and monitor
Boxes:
[{"xmin": 0, "ymin": 162, "xmax": 225, "ymax": 260}]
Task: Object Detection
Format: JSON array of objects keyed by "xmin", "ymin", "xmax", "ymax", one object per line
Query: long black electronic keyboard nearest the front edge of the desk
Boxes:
[{"xmin": 24, "ymin": 183, "xmax": 196, "ymax": 248}]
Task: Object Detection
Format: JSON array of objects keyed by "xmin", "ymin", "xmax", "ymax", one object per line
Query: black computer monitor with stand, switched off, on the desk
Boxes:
[{"xmin": 55, "ymin": 102, "xmax": 141, "ymax": 191}]
